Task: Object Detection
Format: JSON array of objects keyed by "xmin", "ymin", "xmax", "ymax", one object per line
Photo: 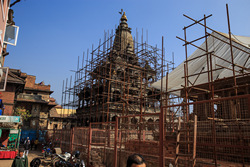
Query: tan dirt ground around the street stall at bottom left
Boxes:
[{"xmin": 0, "ymin": 150, "xmax": 49, "ymax": 167}]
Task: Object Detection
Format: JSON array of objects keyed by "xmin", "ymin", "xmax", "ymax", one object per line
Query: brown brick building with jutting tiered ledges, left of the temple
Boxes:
[{"xmin": 16, "ymin": 75, "xmax": 57, "ymax": 130}]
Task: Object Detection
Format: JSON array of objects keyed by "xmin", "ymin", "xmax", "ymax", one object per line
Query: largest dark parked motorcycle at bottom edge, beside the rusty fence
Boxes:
[{"xmin": 51, "ymin": 151, "xmax": 85, "ymax": 167}]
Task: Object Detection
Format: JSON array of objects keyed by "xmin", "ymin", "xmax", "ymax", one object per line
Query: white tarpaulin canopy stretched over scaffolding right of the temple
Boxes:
[{"xmin": 152, "ymin": 32, "xmax": 250, "ymax": 95}]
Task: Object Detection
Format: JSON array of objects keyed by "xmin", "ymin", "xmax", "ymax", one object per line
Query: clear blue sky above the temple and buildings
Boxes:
[{"xmin": 4, "ymin": 0, "xmax": 250, "ymax": 104}]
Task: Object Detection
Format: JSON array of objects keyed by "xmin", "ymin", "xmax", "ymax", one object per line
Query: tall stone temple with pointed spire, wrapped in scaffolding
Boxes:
[{"xmin": 61, "ymin": 12, "xmax": 163, "ymax": 126}]
